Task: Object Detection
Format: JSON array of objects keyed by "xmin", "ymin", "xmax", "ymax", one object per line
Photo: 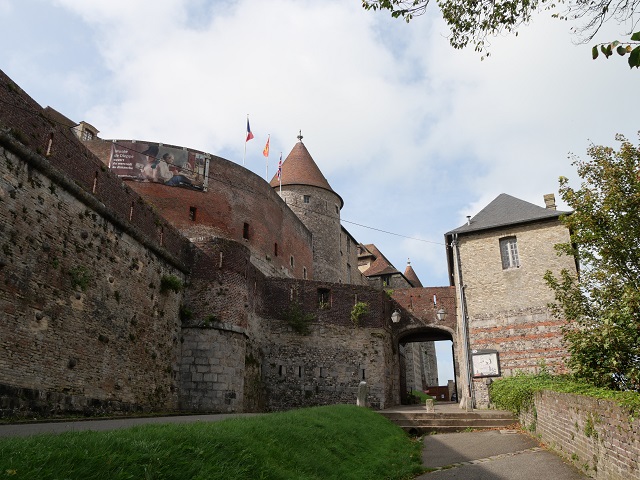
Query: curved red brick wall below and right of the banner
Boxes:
[{"xmin": 86, "ymin": 140, "xmax": 314, "ymax": 279}]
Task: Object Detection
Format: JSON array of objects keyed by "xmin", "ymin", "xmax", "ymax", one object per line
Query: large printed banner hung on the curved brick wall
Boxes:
[{"xmin": 109, "ymin": 141, "xmax": 208, "ymax": 190}]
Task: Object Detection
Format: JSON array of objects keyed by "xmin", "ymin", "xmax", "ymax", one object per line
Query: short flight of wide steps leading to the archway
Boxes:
[{"xmin": 379, "ymin": 406, "xmax": 518, "ymax": 435}]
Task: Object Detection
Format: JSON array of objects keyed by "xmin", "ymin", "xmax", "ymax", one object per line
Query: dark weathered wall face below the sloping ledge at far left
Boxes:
[{"xmin": 0, "ymin": 141, "xmax": 184, "ymax": 415}]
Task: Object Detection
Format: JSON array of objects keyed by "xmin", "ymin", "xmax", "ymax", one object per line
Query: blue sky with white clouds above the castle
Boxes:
[{"xmin": 0, "ymin": 0, "xmax": 640, "ymax": 377}]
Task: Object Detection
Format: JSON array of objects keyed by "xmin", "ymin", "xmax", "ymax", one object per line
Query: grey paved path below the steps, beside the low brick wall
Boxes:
[{"xmin": 416, "ymin": 430, "xmax": 589, "ymax": 480}]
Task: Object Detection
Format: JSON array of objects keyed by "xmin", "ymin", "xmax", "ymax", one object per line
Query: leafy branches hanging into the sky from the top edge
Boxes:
[{"xmin": 362, "ymin": 0, "xmax": 640, "ymax": 67}]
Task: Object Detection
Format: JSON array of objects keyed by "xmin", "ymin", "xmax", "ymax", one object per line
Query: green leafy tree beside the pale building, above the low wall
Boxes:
[{"xmin": 545, "ymin": 136, "xmax": 640, "ymax": 391}]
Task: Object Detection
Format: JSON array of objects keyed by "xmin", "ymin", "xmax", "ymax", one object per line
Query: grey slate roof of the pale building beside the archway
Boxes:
[{"xmin": 445, "ymin": 193, "xmax": 571, "ymax": 235}]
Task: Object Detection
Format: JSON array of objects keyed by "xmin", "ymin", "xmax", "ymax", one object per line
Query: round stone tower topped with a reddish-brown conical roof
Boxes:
[{"xmin": 271, "ymin": 134, "xmax": 344, "ymax": 283}]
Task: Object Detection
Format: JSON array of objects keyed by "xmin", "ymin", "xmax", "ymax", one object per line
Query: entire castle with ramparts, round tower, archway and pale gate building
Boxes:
[{"xmin": 0, "ymin": 72, "xmax": 568, "ymax": 415}]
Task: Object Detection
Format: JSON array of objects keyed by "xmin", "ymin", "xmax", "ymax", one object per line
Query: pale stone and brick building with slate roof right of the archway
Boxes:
[{"xmin": 445, "ymin": 194, "xmax": 577, "ymax": 406}]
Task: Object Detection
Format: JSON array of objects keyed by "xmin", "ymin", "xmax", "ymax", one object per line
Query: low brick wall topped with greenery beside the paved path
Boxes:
[{"xmin": 520, "ymin": 391, "xmax": 640, "ymax": 480}]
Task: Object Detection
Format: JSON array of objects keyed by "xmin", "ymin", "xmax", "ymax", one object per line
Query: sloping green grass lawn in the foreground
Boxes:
[{"xmin": 0, "ymin": 405, "xmax": 423, "ymax": 480}]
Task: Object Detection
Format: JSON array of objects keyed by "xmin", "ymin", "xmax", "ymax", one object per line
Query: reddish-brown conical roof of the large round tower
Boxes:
[{"xmin": 269, "ymin": 135, "xmax": 344, "ymax": 208}]
